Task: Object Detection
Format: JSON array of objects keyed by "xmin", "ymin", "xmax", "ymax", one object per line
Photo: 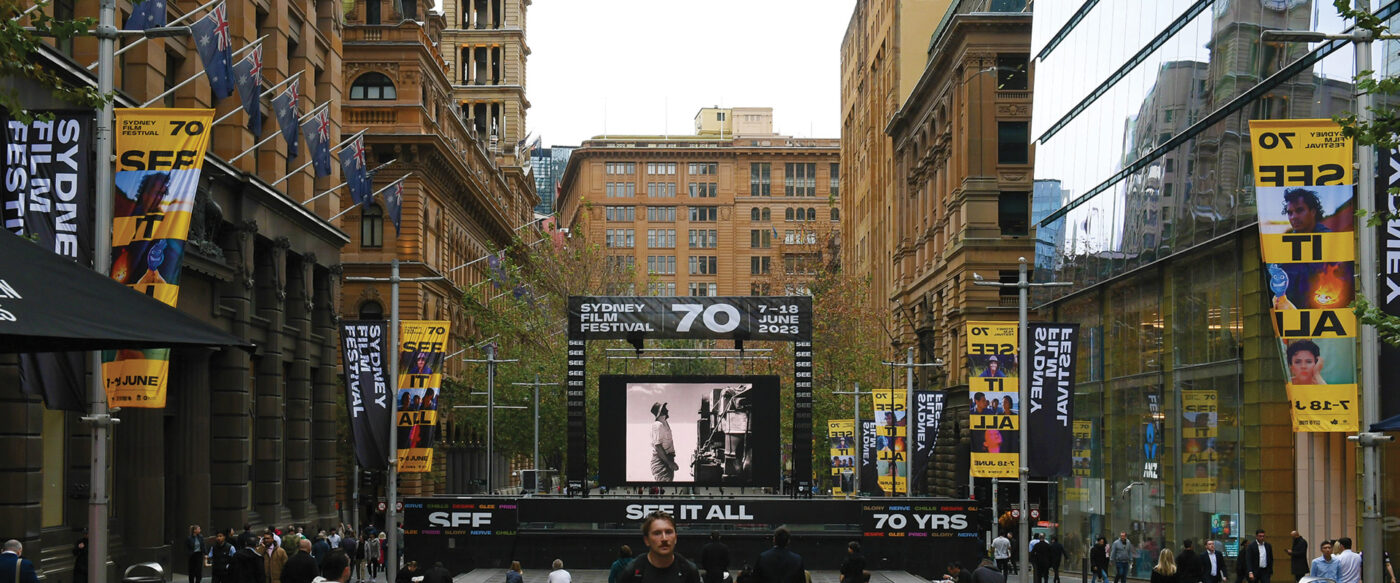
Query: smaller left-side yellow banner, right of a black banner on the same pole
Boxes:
[{"xmin": 393, "ymin": 320, "xmax": 451, "ymax": 472}]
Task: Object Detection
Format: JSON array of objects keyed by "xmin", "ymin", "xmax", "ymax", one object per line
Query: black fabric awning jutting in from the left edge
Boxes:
[{"xmin": 0, "ymin": 231, "xmax": 252, "ymax": 353}]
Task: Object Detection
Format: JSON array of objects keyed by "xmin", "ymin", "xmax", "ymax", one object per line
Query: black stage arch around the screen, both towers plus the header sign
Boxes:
[{"xmin": 564, "ymin": 296, "xmax": 813, "ymax": 498}]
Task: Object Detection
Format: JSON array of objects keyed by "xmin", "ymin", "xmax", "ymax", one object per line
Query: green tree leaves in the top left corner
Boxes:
[{"xmin": 0, "ymin": 0, "xmax": 111, "ymax": 123}]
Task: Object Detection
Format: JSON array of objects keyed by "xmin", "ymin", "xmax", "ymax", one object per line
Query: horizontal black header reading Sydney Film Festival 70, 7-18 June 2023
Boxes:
[{"xmin": 568, "ymin": 296, "xmax": 812, "ymax": 342}]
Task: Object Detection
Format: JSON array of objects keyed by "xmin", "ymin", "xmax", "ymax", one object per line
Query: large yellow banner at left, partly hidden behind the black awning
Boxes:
[{"xmin": 99, "ymin": 108, "xmax": 214, "ymax": 409}]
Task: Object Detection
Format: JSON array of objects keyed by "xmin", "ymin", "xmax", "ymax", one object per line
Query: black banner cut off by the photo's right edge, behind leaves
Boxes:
[{"xmin": 1377, "ymin": 145, "xmax": 1400, "ymax": 420}]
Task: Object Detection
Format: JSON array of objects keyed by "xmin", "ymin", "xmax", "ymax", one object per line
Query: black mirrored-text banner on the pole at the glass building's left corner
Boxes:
[{"xmin": 1026, "ymin": 322, "xmax": 1079, "ymax": 478}]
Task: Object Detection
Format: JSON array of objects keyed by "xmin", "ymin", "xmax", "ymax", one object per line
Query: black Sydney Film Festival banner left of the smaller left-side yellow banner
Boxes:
[{"xmin": 340, "ymin": 320, "xmax": 393, "ymax": 469}]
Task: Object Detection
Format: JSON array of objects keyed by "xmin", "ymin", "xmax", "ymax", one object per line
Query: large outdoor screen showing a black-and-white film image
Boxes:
[{"xmin": 598, "ymin": 374, "xmax": 780, "ymax": 486}]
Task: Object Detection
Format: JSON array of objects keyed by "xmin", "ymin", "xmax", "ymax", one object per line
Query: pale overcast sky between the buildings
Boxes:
[{"xmin": 526, "ymin": 0, "xmax": 857, "ymax": 146}]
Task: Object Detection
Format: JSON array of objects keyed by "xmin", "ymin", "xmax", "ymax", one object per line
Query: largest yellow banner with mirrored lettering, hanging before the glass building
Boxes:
[{"xmin": 1249, "ymin": 119, "xmax": 1359, "ymax": 432}]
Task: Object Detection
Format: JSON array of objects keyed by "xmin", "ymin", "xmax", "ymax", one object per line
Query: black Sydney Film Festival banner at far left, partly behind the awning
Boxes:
[{"xmin": 0, "ymin": 111, "xmax": 94, "ymax": 411}]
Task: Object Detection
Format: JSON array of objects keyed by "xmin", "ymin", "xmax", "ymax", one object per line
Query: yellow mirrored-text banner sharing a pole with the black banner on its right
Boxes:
[{"xmin": 966, "ymin": 322, "xmax": 1021, "ymax": 478}]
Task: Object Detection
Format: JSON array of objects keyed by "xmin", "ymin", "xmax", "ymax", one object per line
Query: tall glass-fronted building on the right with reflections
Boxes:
[{"xmin": 1032, "ymin": 0, "xmax": 1394, "ymax": 568}]
